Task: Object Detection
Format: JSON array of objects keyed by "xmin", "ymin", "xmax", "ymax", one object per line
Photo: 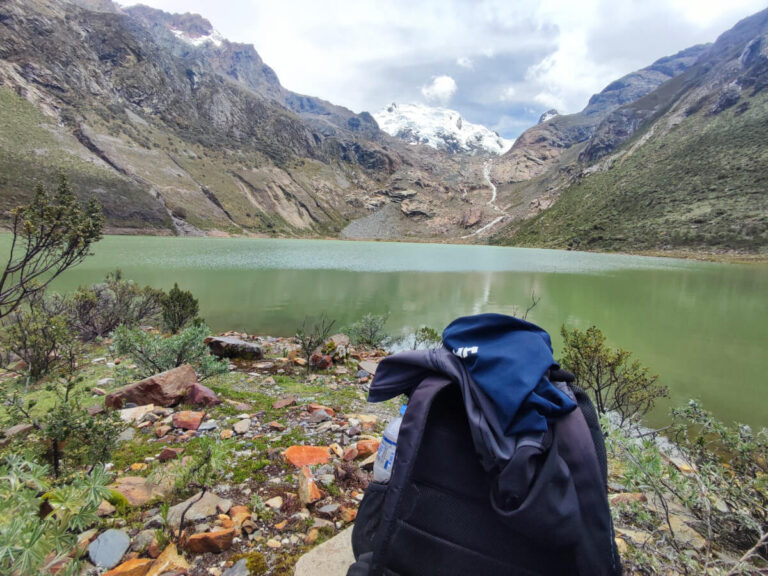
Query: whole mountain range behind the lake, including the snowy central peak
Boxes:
[{"xmin": 0, "ymin": 0, "xmax": 768, "ymax": 252}]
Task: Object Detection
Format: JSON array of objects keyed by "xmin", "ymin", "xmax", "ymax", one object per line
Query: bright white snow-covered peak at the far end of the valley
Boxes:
[{"xmin": 373, "ymin": 103, "xmax": 514, "ymax": 154}]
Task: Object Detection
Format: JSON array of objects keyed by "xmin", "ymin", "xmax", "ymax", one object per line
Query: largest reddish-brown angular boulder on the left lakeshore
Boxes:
[{"xmin": 104, "ymin": 364, "xmax": 198, "ymax": 409}]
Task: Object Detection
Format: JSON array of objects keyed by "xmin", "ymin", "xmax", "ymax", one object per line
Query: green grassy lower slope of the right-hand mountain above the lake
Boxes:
[{"xmin": 504, "ymin": 93, "xmax": 768, "ymax": 252}]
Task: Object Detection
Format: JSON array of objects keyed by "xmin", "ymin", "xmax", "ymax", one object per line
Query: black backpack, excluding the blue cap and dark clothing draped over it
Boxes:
[{"xmin": 347, "ymin": 370, "xmax": 621, "ymax": 576}]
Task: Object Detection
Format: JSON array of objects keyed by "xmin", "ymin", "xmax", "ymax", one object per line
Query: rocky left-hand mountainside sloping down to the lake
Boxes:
[{"xmin": 0, "ymin": 0, "xmax": 482, "ymax": 236}]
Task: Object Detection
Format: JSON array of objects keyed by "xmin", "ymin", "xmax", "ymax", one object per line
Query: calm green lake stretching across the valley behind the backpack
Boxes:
[{"xmin": 24, "ymin": 236, "xmax": 768, "ymax": 426}]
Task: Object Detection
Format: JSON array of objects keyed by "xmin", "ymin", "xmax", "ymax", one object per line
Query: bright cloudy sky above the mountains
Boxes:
[{"xmin": 121, "ymin": 0, "xmax": 766, "ymax": 138}]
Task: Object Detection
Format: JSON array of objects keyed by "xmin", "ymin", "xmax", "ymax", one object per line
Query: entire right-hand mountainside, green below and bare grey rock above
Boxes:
[{"xmin": 494, "ymin": 10, "xmax": 768, "ymax": 252}]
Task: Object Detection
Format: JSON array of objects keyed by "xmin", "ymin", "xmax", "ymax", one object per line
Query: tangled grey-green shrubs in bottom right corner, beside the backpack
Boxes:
[{"xmin": 603, "ymin": 401, "xmax": 768, "ymax": 576}]
